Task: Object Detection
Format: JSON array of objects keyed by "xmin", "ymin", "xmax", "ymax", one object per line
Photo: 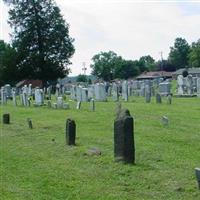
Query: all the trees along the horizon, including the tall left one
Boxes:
[{"xmin": 0, "ymin": 0, "xmax": 200, "ymax": 85}]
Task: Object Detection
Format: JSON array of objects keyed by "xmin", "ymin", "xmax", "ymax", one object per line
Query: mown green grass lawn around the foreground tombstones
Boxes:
[{"xmin": 0, "ymin": 97, "xmax": 200, "ymax": 200}]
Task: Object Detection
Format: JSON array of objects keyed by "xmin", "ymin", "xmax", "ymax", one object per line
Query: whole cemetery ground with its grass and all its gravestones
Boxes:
[{"xmin": 0, "ymin": 77, "xmax": 200, "ymax": 199}]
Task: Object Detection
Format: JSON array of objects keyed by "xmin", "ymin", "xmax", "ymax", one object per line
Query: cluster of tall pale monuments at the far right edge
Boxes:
[{"xmin": 177, "ymin": 74, "xmax": 200, "ymax": 97}]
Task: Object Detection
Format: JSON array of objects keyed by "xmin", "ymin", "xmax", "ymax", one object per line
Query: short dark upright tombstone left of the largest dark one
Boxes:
[{"xmin": 65, "ymin": 119, "xmax": 76, "ymax": 145}]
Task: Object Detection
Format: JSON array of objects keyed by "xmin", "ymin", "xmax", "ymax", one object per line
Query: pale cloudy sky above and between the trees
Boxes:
[{"xmin": 0, "ymin": 0, "xmax": 200, "ymax": 76}]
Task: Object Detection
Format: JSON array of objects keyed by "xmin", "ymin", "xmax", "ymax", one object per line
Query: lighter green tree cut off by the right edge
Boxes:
[{"xmin": 189, "ymin": 39, "xmax": 200, "ymax": 67}]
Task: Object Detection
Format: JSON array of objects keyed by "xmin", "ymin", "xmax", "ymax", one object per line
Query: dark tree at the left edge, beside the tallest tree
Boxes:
[{"xmin": 0, "ymin": 40, "xmax": 19, "ymax": 85}]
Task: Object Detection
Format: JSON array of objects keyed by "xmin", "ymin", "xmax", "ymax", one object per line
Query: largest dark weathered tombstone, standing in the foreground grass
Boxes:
[{"xmin": 114, "ymin": 107, "xmax": 135, "ymax": 164}]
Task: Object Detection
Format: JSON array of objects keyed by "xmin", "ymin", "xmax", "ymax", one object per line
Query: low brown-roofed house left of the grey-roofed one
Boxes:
[{"xmin": 136, "ymin": 71, "xmax": 172, "ymax": 80}]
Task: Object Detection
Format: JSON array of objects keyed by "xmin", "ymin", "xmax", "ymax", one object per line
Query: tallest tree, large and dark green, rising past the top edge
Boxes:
[{"xmin": 4, "ymin": 0, "xmax": 75, "ymax": 82}]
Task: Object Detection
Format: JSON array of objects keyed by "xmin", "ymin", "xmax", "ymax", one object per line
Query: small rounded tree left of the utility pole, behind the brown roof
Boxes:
[{"xmin": 138, "ymin": 55, "xmax": 156, "ymax": 72}]
